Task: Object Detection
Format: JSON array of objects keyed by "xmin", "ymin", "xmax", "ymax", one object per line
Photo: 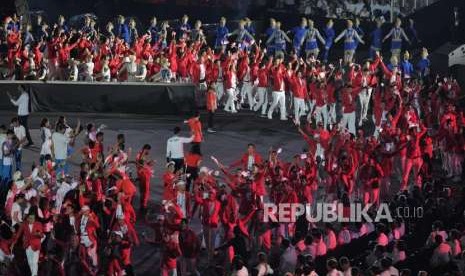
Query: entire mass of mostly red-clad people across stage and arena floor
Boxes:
[{"xmin": 0, "ymin": 8, "xmax": 465, "ymax": 276}]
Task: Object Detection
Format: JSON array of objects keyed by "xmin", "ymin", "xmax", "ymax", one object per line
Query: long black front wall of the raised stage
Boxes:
[{"xmin": 0, "ymin": 81, "xmax": 196, "ymax": 115}]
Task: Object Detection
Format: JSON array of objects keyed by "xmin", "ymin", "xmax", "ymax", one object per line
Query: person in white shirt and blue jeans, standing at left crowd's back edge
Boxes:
[{"xmin": 52, "ymin": 124, "xmax": 71, "ymax": 175}]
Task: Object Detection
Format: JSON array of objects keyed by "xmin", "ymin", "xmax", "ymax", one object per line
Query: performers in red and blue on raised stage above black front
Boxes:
[{"xmin": 0, "ymin": 12, "xmax": 424, "ymax": 83}]
